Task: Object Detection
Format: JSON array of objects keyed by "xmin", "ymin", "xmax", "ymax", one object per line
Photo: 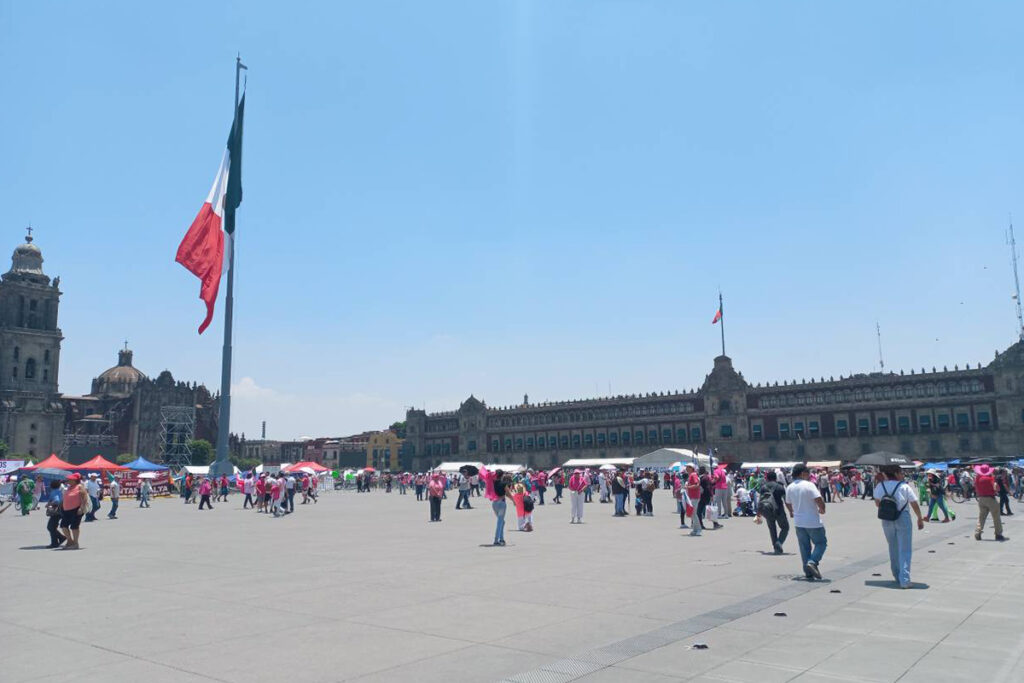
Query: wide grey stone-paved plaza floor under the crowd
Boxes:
[{"xmin": 0, "ymin": 492, "xmax": 1024, "ymax": 683}]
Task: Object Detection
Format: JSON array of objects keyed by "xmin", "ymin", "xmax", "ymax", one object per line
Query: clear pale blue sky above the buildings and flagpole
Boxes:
[{"xmin": 0, "ymin": 0, "xmax": 1024, "ymax": 438}]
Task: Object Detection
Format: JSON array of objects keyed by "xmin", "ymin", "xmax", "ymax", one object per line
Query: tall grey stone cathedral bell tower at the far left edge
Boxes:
[{"xmin": 0, "ymin": 227, "xmax": 63, "ymax": 459}]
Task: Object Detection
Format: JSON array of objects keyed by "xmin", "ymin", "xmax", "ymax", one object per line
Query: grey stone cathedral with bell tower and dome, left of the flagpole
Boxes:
[{"xmin": 0, "ymin": 228, "xmax": 218, "ymax": 463}]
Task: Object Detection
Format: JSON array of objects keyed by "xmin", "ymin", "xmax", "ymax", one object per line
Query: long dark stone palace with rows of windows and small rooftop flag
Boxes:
[{"xmin": 403, "ymin": 341, "xmax": 1024, "ymax": 471}]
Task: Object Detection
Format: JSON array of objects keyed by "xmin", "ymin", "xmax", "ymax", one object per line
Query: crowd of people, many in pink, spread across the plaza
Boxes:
[{"xmin": 8, "ymin": 463, "xmax": 1024, "ymax": 588}]
